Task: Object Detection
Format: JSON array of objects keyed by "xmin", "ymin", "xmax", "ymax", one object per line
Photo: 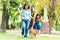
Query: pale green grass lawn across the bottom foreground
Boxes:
[{"xmin": 0, "ymin": 33, "xmax": 60, "ymax": 40}]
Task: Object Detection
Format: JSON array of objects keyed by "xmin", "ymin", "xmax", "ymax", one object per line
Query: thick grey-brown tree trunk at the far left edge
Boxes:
[{"xmin": 0, "ymin": 2, "xmax": 7, "ymax": 32}]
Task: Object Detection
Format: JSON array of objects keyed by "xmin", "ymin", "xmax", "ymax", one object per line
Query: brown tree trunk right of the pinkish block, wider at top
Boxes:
[{"xmin": 47, "ymin": 0, "xmax": 56, "ymax": 33}]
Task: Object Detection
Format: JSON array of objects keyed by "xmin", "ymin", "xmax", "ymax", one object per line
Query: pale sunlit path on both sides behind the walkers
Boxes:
[{"xmin": 6, "ymin": 29, "xmax": 60, "ymax": 37}]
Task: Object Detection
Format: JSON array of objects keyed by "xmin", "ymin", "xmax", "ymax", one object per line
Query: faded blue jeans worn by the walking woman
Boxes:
[{"xmin": 22, "ymin": 19, "xmax": 30, "ymax": 37}]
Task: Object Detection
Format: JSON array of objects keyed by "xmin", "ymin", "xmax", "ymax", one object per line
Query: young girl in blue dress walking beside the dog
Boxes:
[{"xmin": 33, "ymin": 14, "xmax": 40, "ymax": 35}]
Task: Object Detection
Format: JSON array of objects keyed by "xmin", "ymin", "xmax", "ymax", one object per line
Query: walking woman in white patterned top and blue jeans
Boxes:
[{"xmin": 20, "ymin": 3, "xmax": 31, "ymax": 37}]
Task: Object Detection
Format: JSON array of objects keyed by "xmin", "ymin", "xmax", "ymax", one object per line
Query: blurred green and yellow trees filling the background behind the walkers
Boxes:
[{"xmin": 0, "ymin": 0, "xmax": 60, "ymax": 32}]
